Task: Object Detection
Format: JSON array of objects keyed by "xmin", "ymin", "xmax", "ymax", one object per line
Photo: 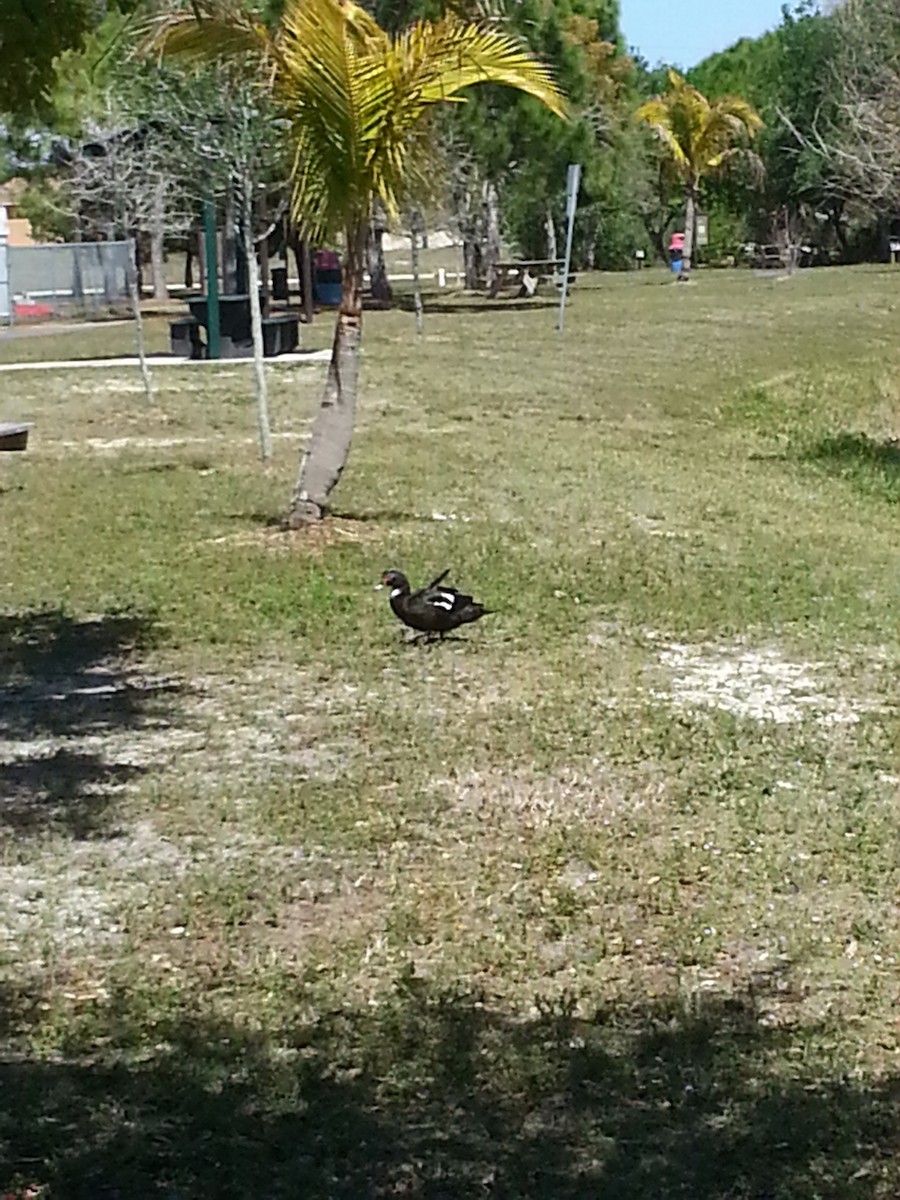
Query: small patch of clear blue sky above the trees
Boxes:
[{"xmin": 620, "ymin": 0, "xmax": 784, "ymax": 67}]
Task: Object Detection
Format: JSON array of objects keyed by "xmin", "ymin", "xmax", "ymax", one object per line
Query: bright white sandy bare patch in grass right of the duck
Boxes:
[{"xmin": 652, "ymin": 641, "xmax": 887, "ymax": 726}]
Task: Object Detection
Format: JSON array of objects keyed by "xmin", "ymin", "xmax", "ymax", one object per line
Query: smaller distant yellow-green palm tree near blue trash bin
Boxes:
[{"xmin": 635, "ymin": 71, "xmax": 762, "ymax": 277}]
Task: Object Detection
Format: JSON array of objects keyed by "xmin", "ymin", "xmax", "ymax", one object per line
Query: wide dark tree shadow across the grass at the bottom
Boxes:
[{"xmin": 0, "ymin": 980, "xmax": 900, "ymax": 1200}]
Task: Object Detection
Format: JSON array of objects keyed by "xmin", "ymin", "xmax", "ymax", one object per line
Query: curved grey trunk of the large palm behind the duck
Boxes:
[{"xmin": 288, "ymin": 221, "xmax": 368, "ymax": 529}]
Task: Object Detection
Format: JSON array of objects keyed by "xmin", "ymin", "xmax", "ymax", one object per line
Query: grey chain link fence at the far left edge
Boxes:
[{"xmin": 6, "ymin": 241, "xmax": 134, "ymax": 322}]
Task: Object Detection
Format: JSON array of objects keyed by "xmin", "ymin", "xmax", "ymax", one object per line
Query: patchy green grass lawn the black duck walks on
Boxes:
[{"xmin": 0, "ymin": 269, "xmax": 900, "ymax": 1200}]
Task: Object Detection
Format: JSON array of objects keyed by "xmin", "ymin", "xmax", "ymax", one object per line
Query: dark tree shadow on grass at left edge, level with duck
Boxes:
[{"xmin": 0, "ymin": 608, "xmax": 180, "ymax": 836}]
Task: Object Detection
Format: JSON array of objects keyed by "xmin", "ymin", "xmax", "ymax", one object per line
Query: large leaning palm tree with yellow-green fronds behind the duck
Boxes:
[{"xmin": 156, "ymin": 0, "xmax": 565, "ymax": 527}]
